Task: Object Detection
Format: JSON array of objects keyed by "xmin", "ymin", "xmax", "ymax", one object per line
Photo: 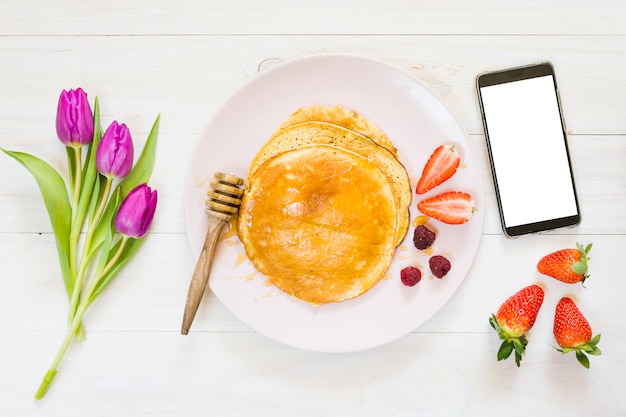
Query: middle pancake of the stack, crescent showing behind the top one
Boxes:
[{"xmin": 248, "ymin": 118, "xmax": 413, "ymax": 246}]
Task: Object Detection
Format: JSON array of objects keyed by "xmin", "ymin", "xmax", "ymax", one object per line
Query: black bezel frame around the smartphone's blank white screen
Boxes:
[{"xmin": 476, "ymin": 62, "xmax": 581, "ymax": 237}]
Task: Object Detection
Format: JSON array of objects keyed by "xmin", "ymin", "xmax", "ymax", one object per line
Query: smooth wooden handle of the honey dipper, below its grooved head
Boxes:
[{"xmin": 180, "ymin": 212, "xmax": 231, "ymax": 335}]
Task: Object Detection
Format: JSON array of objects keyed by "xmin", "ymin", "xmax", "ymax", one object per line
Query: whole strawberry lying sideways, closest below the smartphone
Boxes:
[{"xmin": 537, "ymin": 243, "xmax": 592, "ymax": 284}]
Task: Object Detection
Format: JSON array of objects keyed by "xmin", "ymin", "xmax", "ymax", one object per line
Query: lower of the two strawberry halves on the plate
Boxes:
[{"xmin": 417, "ymin": 191, "xmax": 476, "ymax": 224}]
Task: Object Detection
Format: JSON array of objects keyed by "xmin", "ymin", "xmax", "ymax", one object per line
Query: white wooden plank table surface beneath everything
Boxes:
[{"xmin": 0, "ymin": 0, "xmax": 626, "ymax": 417}]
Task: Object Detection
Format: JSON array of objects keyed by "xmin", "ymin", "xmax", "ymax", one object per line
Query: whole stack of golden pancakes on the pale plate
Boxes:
[{"xmin": 237, "ymin": 106, "xmax": 412, "ymax": 304}]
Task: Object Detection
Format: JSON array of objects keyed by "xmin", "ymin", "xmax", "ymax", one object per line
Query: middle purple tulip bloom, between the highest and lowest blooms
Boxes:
[{"xmin": 96, "ymin": 121, "xmax": 134, "ymax": 178}]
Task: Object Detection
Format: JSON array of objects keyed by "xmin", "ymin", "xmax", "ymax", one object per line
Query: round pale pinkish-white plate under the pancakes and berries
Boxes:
[{"xmin": 185, "ymin": 54, "xmax": 484, "ymax": 352}]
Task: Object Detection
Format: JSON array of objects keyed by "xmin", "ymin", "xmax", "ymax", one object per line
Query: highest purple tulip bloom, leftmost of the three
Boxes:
[{"xmin": 56, "ymin": 88, "xmax": 94, "ymax": 146}]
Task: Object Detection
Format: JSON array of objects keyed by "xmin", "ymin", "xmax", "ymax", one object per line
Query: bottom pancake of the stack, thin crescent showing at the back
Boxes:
[{"xmin": 279, "ymin": 104, "xmax": 398, "ymax": 157}]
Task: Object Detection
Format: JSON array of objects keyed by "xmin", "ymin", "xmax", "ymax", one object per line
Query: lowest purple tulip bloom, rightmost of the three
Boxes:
[{"xmin": 115, "ymin": 184, "xmax": 157, "ymax": 239}]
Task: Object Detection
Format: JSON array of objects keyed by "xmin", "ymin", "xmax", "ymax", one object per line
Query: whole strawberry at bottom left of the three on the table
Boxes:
[{"xmin": 489, "ymin": 285, "xmax": 544, "ymax": 367}]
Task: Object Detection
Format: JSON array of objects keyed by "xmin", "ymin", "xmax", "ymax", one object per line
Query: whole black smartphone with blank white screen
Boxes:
[{"xmin": 476, "ymin": 63, "xmax": 580, "ymax": 236}]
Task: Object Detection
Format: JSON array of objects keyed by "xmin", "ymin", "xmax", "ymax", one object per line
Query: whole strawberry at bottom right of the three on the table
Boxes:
[{"xmin": 554, "ymin": 297, "xmax": 602, "ymax": 368}]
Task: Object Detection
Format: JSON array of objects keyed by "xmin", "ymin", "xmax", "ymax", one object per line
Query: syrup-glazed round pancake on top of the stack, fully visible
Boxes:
[{"xmin": 237, "ymin": 144, "xmax": 397, "ymax": 304}]
